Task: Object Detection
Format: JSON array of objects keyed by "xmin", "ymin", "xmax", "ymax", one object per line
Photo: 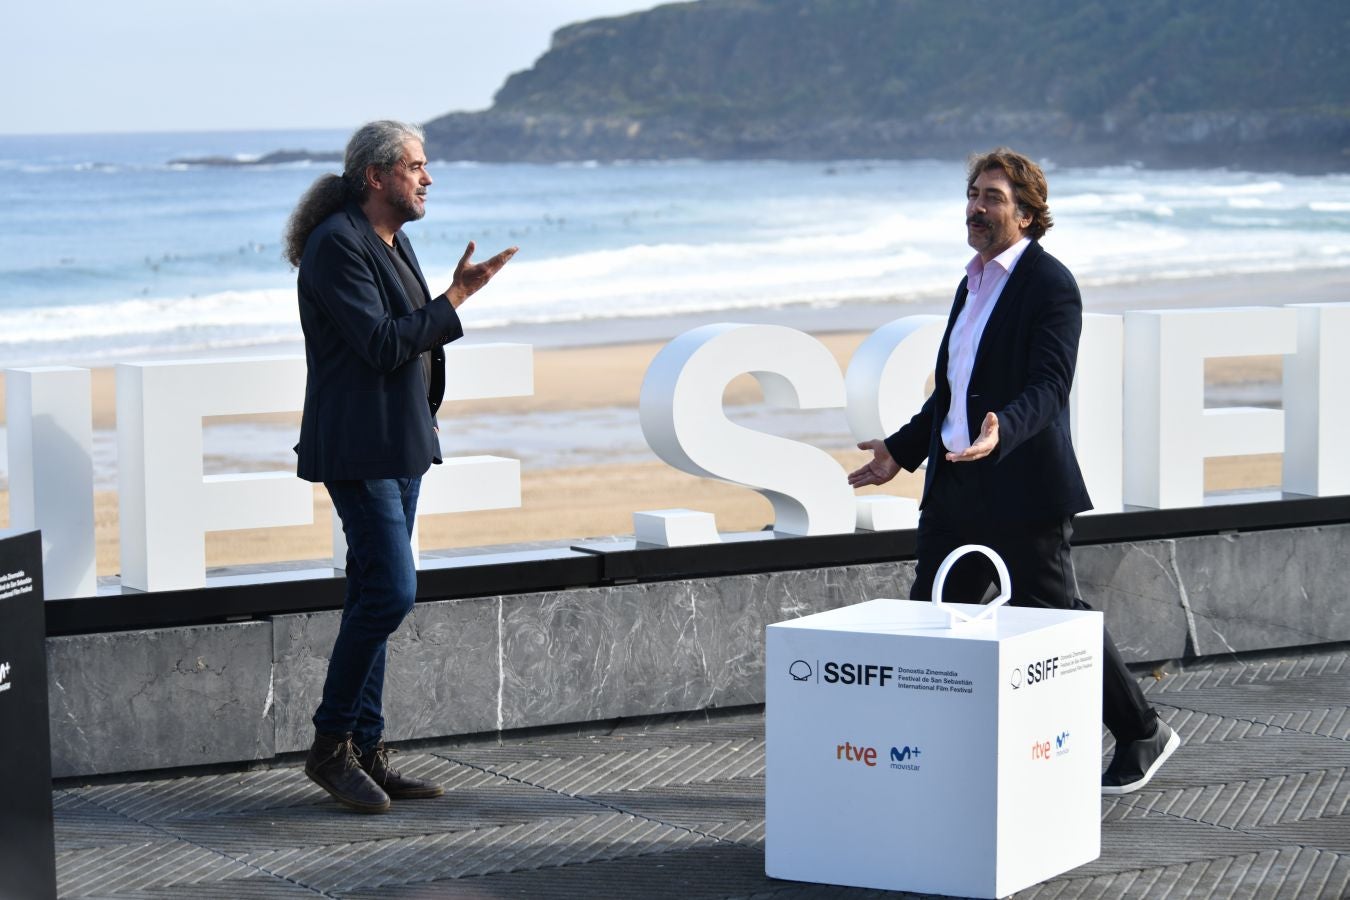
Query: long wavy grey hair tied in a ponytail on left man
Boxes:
[{"xmin": 284, "ymin": 119, "xmax": 425, "ymax": 267}]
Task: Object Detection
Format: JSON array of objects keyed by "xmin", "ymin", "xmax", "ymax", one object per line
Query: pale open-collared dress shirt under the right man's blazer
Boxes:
[{"xmin": 942, "ymin": 237, "xmax": 1031, "ymax": 453}]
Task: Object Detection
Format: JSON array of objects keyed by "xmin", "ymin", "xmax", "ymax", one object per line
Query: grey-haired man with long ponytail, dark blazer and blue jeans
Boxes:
[{"xmin": 286, "ymin": 121, "xmax": 516, "ymax": 812}]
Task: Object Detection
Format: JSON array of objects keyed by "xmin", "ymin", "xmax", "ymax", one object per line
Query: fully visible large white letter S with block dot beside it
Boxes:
[{"xmin": 635, "ymin": 324, "xmax": 856, "ymax": 544}]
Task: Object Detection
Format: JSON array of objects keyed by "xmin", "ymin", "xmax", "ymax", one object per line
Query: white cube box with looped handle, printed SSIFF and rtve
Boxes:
[{"xmin": 764, "ymin": 548, "xmax": 1102, "ymax": 897}]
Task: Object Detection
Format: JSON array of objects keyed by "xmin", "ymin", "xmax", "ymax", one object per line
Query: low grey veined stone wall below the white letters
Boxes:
[{"xmin": 47, "ymin": 525, "xmax": 1350, "ymax": 777}]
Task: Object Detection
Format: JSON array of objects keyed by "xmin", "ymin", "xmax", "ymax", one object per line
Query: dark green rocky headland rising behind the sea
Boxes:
[{"xmin": 427, "ymin": 0, "xmax": 1350, "ymax": 170}]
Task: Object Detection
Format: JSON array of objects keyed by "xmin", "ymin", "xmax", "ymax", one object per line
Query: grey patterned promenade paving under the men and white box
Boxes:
[{"xmin": 53, "ymin": 644, "xmax": 1350, "ymax": 900}]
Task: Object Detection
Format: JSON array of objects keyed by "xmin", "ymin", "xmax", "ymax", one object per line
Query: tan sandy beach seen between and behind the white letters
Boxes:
[{"xmin": 0, "ymin": 269, "xmax": 1332, "ymax": 576}]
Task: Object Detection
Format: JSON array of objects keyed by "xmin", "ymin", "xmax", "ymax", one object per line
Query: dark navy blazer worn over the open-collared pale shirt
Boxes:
[{"xmin": 886, "ymin": 240, "xmax": 1092, "ymax": 522}]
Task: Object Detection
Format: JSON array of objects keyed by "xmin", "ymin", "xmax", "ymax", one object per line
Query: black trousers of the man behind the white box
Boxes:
[{"xmin": 910, "ymin": 460, "xmax": 1157, "ymax": 743}]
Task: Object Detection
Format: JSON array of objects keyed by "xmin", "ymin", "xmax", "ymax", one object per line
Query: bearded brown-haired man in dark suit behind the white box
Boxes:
[{"xmin": 849, "ymin": 148, "xmax": 1181, "ymax": 793}]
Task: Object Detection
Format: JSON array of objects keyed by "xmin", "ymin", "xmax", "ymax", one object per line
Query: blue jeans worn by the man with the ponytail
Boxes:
[{"xmin": 315, "ymin": 475, "xmax": 421, "ymax": 753}]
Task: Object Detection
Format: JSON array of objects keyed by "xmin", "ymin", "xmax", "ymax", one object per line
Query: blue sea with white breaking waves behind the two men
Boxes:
[{"xmin": 0, "ymin": 131, "xmax": 1350, "ymax": 367}]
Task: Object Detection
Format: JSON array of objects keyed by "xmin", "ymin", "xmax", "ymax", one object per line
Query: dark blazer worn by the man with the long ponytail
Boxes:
[{"xmin": 296, "ymin": 204, "xmax": 464, "ymax": 482}]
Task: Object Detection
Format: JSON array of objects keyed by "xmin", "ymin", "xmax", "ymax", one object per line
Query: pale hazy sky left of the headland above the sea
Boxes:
[{"xmin": 0, "ymin": 0, "xmax": 672, "ymax": 134}]
